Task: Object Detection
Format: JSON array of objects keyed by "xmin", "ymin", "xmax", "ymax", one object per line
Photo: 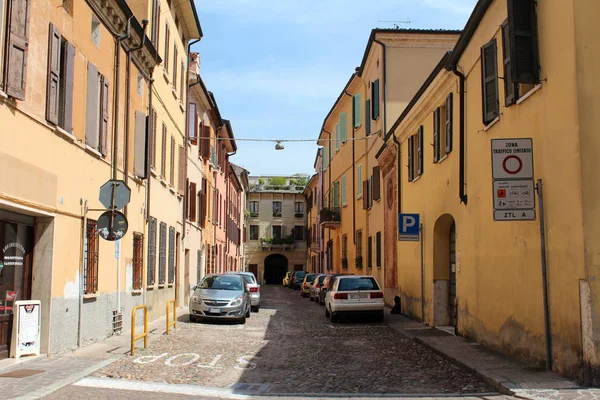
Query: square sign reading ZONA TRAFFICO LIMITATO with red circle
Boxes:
[{"xmin": 492, "ymin": 139, "xmax": 533, "ymax": 179}]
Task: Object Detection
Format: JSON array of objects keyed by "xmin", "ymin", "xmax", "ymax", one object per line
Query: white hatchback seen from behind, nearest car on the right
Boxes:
[{"xmin": 325, "ymin": 275, "xmax": 385, "ymax": 322}]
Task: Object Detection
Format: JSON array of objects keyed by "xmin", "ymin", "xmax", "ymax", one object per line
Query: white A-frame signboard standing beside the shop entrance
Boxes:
[{"xmin": 10, "ymin": 300, "xmax": 42, "ymax": 358}]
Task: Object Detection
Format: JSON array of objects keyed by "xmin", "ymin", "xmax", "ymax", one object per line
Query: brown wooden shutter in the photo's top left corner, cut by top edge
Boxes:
[{"xmin": 0, "ymin": 0, "xmax": 32, "ymax": 100}]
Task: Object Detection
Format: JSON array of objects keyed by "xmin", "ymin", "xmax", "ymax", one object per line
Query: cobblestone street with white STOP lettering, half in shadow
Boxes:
[{"xmin": 39, "ymin": 285, "xmax": 504, "ymax": 400}]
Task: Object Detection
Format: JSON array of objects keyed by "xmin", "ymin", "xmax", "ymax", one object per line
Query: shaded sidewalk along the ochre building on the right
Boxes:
[{"xmin": 385, "ymin": 307, "xmax": 600, "ymax": 398}]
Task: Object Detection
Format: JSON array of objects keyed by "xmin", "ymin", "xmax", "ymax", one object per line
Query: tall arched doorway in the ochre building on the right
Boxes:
[{"xmin": 433, "ymin": 214, "xmax": 458, "ymax": 329}]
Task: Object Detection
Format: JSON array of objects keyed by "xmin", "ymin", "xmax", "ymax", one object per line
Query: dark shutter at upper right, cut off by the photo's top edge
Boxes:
[{"xmin": 508, "ymin": 0, "xmax": 540, "ymax": 85}]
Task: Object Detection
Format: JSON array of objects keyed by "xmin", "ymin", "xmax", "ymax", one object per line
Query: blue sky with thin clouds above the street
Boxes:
[{"xmin": 192, "ymin": 0, "xmax": 476, "ymax": 175}]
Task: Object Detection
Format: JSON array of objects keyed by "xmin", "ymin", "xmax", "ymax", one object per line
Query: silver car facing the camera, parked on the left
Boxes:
[{"xmin": 190, "ymin": 274, "xmax": 250, "ymax": 324}]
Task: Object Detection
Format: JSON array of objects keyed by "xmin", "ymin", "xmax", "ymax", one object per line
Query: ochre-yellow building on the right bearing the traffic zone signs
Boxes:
[{"xmin": 378, "ymin": 0, "xmax": 600, "ymax": 383}]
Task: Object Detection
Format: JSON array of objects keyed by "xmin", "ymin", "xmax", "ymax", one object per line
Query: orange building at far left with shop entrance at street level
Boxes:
[{"xmin": 0, "ymin": 0, "xmax": 161, "ymax": 358}]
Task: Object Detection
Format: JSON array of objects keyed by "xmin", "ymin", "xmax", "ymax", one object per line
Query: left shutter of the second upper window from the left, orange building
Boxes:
[{"xmin": 46, "ymin": 22, "xmax": 62, "ymax": 125}]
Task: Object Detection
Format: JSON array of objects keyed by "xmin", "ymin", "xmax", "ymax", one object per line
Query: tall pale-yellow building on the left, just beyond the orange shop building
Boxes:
[{"xmin": 128, "ymin": 0, "xmax": 202, "ymax": 318}]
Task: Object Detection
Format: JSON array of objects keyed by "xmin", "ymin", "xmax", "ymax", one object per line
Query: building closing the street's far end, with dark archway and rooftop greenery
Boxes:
[{"xmin": 245, "ymin": 176, "xmax": 307, "ymax": 284}]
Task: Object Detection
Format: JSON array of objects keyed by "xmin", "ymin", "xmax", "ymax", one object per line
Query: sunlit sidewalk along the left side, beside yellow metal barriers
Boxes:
[{"xmin": 0, "ymin": 307, "xmax": 187, "ymax": 400}]
